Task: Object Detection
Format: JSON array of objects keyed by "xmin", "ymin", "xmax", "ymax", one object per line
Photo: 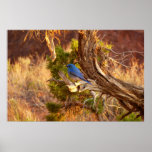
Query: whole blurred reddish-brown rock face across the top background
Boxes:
[{"xmin": 8, "ymin": 30, "xmax": 144, "ymax": 63}]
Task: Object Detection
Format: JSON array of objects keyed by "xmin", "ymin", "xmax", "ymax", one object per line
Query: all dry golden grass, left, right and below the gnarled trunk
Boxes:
[{"xmin": 8, "ymin": 57, "xmax": 144, "ymax": 121}]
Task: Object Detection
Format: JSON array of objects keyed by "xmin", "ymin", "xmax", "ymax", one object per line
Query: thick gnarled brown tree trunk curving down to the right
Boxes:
[{"xmin": 78, "ymin": 30, "xmax": 144, "ymax": 118}]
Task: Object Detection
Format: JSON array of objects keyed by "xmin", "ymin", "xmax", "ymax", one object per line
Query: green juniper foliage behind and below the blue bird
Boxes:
[{"xmin": 46, "ymin": 39, "xmax": 96, "ymax": 121}]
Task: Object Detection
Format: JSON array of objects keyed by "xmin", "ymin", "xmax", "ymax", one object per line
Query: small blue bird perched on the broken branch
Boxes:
[{"xmin": 67, "ymin": 64, "xmax": 91, "ymax": 84}]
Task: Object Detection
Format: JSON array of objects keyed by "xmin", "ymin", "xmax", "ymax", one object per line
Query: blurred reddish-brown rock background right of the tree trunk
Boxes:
[{"xmin": 98, "ymin": 30, "xmax": 144, "ymax": 63}]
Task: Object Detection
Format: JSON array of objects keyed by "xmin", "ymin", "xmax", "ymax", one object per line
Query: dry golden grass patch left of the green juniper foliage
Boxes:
[{"xmin": 8, "ymin": 58, "xmax": 52, "ymax": 121}]
